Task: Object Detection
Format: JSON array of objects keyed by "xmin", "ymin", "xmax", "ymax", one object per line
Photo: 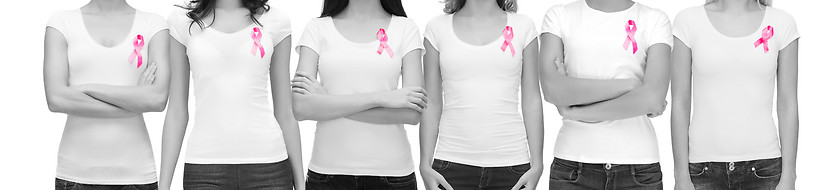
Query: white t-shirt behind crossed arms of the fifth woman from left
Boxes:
[{"xmin": 542, "ymin": 0, "xmax": 673, "ymax": 164}]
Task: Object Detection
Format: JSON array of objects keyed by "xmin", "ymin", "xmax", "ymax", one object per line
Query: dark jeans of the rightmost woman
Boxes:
[{"xmin": 688, "ymin": 158, "xmax": 782, "ymax": 190}]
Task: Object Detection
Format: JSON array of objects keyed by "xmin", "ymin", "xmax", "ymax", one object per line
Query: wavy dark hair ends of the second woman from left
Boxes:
[{"xmin": 175, "ymin": 0, "xmax": 271, "ymax": 29}]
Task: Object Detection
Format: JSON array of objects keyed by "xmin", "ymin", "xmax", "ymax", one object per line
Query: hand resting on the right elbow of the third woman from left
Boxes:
[{"xmin": 376, "ymin": 87, "xmax": 427, "ymax": 113}]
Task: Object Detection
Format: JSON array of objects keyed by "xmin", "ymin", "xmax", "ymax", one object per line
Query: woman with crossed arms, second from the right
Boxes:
[{"xmin": 540, "ymin": 0, "xmax": 672, "ymax": 189}]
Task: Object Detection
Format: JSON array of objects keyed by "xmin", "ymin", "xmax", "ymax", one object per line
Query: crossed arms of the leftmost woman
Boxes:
[{"xmin": 44, "ymin": 27, "xmax": 169, "ymax": 118}]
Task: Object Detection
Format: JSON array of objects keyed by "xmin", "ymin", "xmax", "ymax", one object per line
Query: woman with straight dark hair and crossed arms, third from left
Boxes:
[{"xmin": 292, "ymin": 0, "xmax": 426, "ymax": 190}]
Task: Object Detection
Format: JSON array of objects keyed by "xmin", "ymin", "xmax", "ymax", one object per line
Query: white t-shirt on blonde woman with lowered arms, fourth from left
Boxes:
[{"xmin": 425, "ymin": 13, "xmax": 537, "ymax": 167}]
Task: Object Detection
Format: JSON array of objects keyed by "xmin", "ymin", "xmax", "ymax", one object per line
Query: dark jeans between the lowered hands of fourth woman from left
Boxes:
[{"xmin": 432, "ymin": 159, "xmax": 531, "ymax": 190}]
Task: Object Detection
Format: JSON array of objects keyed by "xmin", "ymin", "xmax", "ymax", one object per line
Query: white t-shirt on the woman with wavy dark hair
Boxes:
[{"xmin": 169, "ymin": 8, "xmax": 291, "ymax": 164}]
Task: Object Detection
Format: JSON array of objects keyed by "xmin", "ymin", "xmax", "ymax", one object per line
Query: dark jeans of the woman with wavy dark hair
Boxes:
[{"xmin": 184, "ymin": 160, "xmax": 294, "ymax": 190}]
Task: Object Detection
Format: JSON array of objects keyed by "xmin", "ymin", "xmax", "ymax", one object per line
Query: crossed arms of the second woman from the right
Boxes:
[{"xmin": 540, "ymin": 33, "xmax": 671, "ymax": 121}]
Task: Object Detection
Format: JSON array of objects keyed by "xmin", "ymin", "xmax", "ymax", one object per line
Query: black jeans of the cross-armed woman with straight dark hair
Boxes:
[{"xmin": 306, "ymin": 170, "xmax": 417, "ymax": 190}]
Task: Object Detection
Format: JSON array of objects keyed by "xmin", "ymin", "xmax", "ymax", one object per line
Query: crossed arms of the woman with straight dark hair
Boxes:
[{"xmin": 292, "ymin": 46, "xmax": 426, "ymax": 125}]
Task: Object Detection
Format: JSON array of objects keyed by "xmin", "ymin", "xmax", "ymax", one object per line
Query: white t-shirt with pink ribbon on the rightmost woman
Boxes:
[{"xmin": 674, "ymin": 6, "xmax": 799, "ymax": 163}]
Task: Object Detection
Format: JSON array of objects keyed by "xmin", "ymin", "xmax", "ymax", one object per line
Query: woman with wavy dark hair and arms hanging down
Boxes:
[{"xmin": 161, "ymin": 0, "xmax": 304, "ymax": 189}]
